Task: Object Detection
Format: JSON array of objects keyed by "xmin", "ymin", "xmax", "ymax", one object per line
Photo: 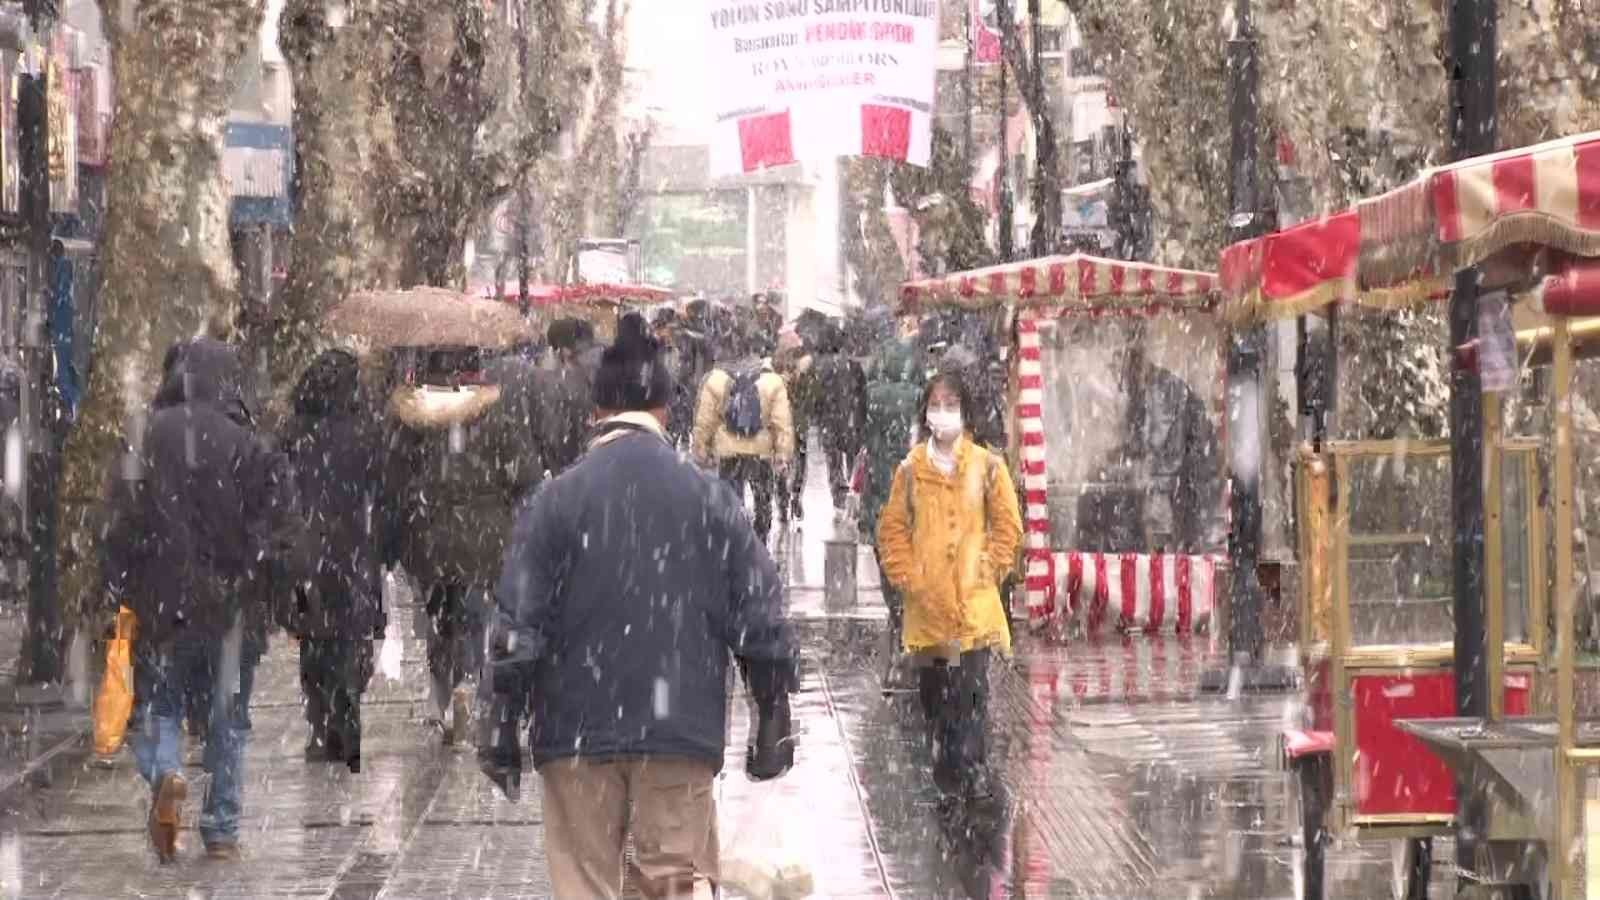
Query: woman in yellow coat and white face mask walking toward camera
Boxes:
[{"xmin": 878, "ymin": 373, "xmax": 1022, "ymax": 798}]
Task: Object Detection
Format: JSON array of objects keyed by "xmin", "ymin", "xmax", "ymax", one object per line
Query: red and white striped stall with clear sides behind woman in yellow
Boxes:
[{"xmin": 901, "ymin": 248, "xmax": 1227, "ymax": 633}]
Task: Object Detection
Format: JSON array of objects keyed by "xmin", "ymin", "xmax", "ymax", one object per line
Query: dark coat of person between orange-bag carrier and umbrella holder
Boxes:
[{"xmin": 278, "ymin": 351, "xmax": 386, "ymax": 641}]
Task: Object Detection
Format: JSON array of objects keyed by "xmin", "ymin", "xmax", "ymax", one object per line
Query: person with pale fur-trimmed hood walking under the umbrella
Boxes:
[{"xmin": 387, "ymin": 342, "xmax": 544, "ymax": 743}]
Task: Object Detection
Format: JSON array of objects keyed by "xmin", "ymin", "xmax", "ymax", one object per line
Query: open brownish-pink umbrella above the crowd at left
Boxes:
[{"xmin": 323, "ymin": 288, "xmax": 536, "ymax": 348}]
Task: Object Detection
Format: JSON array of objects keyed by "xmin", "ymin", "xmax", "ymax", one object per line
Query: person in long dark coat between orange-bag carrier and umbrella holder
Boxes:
[{"xmin": 282, "ymin": 351, "xmax": 387, "ymax": 772}]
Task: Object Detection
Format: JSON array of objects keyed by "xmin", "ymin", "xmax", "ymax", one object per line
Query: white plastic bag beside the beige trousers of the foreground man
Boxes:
[{"xmin": 717, "ymin": 778, "xmax": 816, "ymax": 900}]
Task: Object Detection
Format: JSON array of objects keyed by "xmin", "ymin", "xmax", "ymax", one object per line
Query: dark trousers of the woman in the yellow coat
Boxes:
[{"xmin": 918, "ymin": 650, "xmax": 990, "ymax": 796}]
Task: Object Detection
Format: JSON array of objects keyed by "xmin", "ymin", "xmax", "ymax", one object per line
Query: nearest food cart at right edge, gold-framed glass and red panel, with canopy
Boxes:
[{"xmin": 1222, "ymin": 135, "xmax": 1600, "ymax": 898}]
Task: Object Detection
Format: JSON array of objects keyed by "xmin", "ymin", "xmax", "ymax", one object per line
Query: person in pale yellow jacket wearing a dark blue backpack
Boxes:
[{"xmin": 694, "ymin": 328, "xmax": 795, "ymax": 541}]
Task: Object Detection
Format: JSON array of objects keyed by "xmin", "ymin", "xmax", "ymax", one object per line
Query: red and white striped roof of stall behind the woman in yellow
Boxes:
[{"xmin": 901, "ymin": 253, "xmax": 1218, "ymax": 314}]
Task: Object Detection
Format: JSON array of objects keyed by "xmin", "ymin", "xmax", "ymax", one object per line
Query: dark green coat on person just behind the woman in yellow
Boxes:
[{"xmin": 861, "ymin": 341, "xmax": 922, "ymax": 535}]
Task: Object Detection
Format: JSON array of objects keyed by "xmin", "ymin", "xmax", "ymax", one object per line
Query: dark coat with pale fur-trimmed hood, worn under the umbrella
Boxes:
[{"xmin": 386, "ymin": 373, "xmax": 544, "ymax": 588}]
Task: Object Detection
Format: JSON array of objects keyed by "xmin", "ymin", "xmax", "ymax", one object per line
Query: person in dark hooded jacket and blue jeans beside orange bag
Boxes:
[{"xmin": 102, "ymin": 338, "xmax": 296, "ymax": 862}]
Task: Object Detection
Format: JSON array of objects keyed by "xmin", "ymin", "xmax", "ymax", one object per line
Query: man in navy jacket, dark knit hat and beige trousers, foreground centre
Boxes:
[{"xmin": 480, "ymin": 315, "xmax": 797, "ymax": 898}]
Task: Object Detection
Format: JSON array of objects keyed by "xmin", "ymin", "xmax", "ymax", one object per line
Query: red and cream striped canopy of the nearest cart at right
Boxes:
[{"xmin": 1221, "ymin": 131, "xmax": 1600, "ymax": 319}]
